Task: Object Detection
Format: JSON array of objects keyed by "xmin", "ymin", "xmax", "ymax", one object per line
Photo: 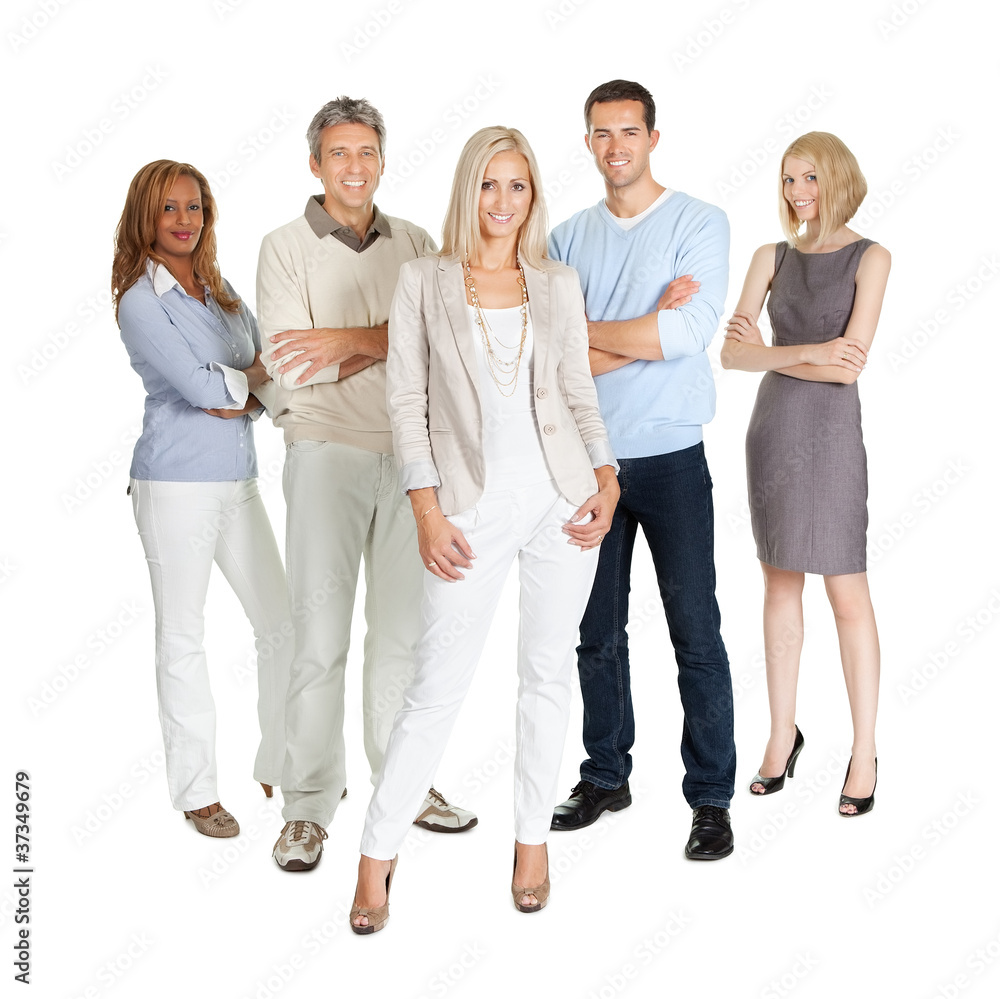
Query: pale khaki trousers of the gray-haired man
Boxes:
[{"xmin": 281, "ymin": 441, "xmax": 430, "ymax": 827}]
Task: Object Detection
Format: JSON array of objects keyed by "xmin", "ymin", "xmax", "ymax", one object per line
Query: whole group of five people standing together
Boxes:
[{"xmin": 113, "ymin": 80, "xmax": 889, "ymax": 933}]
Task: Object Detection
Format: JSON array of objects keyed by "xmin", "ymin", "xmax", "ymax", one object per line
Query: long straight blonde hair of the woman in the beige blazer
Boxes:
[{"xmin": 441, "ymin": 125, "xmax": 550, "ymax": 269}]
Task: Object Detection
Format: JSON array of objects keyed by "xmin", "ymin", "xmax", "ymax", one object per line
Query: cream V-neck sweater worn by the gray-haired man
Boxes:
[{"xmin": 257, "ymin": 216, "xmax": 434, "ymax": 454}]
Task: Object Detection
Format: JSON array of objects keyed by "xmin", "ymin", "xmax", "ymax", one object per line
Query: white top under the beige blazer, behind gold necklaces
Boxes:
[{"xmin": 467, "ymin": 305, "xmax": 552, "ymax": 491}]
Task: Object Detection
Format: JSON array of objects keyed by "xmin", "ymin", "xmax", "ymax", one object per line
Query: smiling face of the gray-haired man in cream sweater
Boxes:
[{"xmin": 309, "ymin": 122, "xmax": 384, "ymax": 225}]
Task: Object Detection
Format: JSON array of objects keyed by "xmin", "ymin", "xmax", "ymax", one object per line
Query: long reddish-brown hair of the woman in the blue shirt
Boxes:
[{"xmin": 111, "ymin": 160, "xmax": 240, "ymax": 319}]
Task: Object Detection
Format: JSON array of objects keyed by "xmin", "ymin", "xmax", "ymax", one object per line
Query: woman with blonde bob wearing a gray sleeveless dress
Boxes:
[{"xmin": 722, "ymin": 132, "xmax": 890, "ymax": 816}]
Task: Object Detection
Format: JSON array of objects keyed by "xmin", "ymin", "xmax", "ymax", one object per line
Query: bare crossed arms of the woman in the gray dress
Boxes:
[{"xmin": 721, "ymin": 243, "xmax": 891, "ymax": 385}]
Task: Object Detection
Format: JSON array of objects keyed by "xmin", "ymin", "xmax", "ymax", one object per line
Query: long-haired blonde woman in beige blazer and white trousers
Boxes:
[{"xmin": 350, "ymin": 127, "xmax": 618, "ymax": 933}]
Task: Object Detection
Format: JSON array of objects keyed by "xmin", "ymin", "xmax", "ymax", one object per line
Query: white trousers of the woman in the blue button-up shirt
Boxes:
[{"xmin": 130, "ymin": 479, "xmax": 294, "ymax": 810}]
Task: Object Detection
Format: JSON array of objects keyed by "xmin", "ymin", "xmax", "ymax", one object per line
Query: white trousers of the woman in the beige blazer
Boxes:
[{"xmin": 361, "ymin": 483, "xmax": 599, "ymax": 860}]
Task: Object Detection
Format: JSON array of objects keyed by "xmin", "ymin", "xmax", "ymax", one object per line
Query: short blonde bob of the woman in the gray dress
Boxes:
[{"xmin": 778, "ymin": 132, "xmax": 868, "ymax": 246}]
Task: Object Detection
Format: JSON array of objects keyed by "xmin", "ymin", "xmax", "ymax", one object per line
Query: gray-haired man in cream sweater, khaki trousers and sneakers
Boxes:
[{"xmin": 257, "ymin": 97, "xmax": 477, "ymax": 871}]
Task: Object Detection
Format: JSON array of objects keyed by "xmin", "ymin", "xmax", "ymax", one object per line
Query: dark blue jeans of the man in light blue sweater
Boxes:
[{"xmin": 577, "ymin": 444, "xmax": 736, "ymax": 808}]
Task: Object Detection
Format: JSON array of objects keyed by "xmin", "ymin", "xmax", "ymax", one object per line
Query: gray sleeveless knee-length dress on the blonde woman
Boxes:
[{"xmin": 746, "ymin": 239, "xmax": 873, "ymax": 576}]
